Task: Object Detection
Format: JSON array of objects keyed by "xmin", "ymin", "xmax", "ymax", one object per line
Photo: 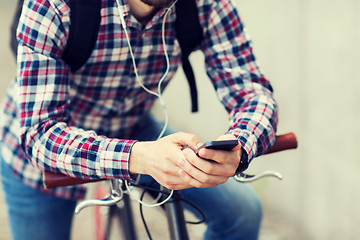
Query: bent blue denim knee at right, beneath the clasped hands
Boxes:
[{"xmin": 181, "ymin": 178, "xmax": 262, "ymax": 240}]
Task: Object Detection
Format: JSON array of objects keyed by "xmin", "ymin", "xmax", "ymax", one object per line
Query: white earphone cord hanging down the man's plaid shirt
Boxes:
[{"xmin": 116, "ymin": 0, "xmax": 177, "ymax": 207}]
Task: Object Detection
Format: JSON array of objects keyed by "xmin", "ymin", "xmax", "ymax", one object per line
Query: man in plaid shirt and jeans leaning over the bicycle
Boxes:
[{"xmin": 0, "ymin": 0, "xmax": 277, "ymax": 239}]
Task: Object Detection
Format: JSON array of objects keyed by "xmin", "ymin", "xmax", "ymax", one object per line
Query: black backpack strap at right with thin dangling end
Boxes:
[{"xmin": 175, "ymin": 0, "xmax": 203, "ymax": 112}]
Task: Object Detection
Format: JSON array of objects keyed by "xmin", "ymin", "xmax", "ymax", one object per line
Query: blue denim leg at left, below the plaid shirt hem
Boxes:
[{"xmin": 0, "ymin": 157, "xmax": 76, "ymax": 240}]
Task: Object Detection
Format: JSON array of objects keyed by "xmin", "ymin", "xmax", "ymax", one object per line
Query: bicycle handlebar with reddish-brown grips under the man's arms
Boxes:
[{"xmin": 43, "ymin": 132, "xmax": 297, "ymax": 189}]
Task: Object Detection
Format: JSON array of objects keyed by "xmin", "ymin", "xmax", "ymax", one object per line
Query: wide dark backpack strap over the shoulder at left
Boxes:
[{"xmin": 62, "ymin": 0, "xmax": 101, "ymax": 72}]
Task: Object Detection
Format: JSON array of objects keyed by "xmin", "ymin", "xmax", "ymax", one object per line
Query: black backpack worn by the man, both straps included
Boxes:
[{"xmin": 10, "ymin": 0, "xmax": 203, "ymax": 112}]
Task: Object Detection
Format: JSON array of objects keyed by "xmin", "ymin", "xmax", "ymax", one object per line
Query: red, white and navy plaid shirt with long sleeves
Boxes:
[{"xmin": 0, "ymin": 0, "xmax": 277, "ymax": 199}]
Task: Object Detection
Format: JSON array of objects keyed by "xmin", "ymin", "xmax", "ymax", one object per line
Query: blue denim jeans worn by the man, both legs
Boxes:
[{"xmin": 0, "ymin": 117, "xmax": 262, "ymax": 240}]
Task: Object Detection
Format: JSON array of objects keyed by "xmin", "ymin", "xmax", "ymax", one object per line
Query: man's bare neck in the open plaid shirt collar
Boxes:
[{"xmin": 126, "ymin": 0, "xmax": 157, "ymax": 25}]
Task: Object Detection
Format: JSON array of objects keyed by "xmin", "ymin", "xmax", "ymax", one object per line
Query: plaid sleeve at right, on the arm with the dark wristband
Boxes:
[{"xmin": 200, "ymin": 0, "xmax": 277, "ymax": 168}]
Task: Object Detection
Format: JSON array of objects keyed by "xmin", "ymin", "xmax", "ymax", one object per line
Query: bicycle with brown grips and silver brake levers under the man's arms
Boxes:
[{"xmin": 43, "ymin": 133, "xmax": 297, "ymax": 240}]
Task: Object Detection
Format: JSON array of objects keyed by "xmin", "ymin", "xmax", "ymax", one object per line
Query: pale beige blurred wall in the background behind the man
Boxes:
[{"xmin": 0, "ymin": 0, "xmax": 360, "ymax": 240}]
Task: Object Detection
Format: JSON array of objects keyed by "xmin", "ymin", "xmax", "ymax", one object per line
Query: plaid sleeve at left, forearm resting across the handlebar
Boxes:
[{"xmin": 17, "ymin": 0, "xmax": 134, "ymax": 179}]
